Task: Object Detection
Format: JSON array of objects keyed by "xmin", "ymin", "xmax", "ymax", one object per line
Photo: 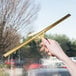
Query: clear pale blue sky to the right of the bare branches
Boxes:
[{"xmin": 35, "ymin": 0, "xmax": 76, "ymax": 39}]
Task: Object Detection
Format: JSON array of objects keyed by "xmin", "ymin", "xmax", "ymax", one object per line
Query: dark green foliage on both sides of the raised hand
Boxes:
[{"xmin": 17, "ymin": 34, "xmax": 76, "ymax": 59}]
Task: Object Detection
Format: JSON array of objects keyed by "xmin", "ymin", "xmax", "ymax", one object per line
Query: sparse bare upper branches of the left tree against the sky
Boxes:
[{"xmin": 0, "ymin": 0, "xmax": 39, "ymax": 35}]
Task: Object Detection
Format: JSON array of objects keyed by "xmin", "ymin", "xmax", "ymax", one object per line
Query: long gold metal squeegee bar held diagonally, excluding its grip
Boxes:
[{"xmin": 3, "ymin": 14, "xmax": 71, "ymax": 57}]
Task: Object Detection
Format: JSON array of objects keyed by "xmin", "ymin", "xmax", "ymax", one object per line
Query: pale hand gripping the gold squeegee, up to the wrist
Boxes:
[{"xmin": 40, "ymin": 38, "xmax": 66, "ymax": 60}]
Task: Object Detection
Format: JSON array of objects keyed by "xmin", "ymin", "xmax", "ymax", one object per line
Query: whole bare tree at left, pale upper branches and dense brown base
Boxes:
[{"xmin": 0, "ymin": 0, "xmax": 39, "ymax": 57}]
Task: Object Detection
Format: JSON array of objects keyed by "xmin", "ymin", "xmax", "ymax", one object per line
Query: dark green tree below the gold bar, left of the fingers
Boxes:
[{"xmin": 20, "ymin": 39, "xmax": 42, "ymax": 59}]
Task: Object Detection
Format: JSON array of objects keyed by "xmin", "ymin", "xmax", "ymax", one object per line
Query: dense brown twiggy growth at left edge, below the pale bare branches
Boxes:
[{"xmin": 0, "ymin": 27, "xmax": 21, "ymax": 56}]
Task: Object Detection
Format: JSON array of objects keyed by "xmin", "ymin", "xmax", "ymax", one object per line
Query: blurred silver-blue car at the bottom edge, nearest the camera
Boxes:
[{"xmin": 26, "ymin": 68, "xmax": 71, "ymax": 76}]
